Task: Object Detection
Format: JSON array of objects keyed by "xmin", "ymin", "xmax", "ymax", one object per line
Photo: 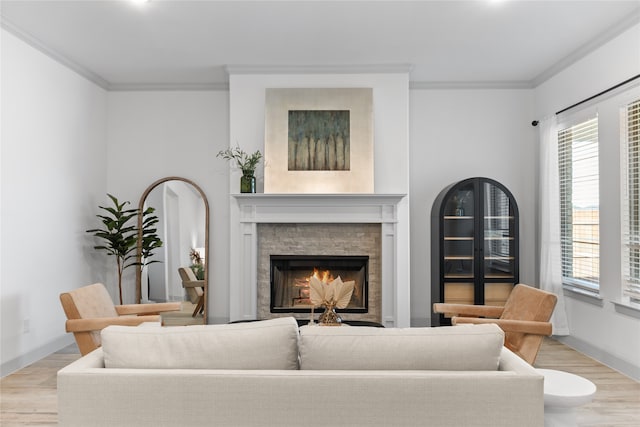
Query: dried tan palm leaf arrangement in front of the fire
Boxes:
[{"xmin": 309, "ymin": 275, "xmax": 355, "ymax": 326}]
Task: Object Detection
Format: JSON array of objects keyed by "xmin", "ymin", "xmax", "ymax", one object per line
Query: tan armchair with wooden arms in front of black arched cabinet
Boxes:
[{"xmin": 433, "ymin": 284, "xmax": 558, "ymax": 365}]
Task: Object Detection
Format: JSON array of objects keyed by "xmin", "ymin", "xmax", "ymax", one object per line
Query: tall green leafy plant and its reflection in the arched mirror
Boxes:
[{"xmin": 87, "ymin": 194, "xmax": 162, "ymax": 304}]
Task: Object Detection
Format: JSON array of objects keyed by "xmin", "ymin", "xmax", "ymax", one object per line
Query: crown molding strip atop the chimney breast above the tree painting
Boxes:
[{"xmin": 224, "ymin": 64, "xmax": 413, "ymax": 76}]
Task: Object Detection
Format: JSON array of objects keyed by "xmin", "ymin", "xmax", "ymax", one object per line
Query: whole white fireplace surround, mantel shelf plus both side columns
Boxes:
[{"xmin": 229, "ymin": 194, "xmax": 410, "ymax": 327}]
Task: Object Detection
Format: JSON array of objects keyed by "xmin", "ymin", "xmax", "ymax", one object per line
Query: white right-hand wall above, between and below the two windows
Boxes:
[{"xmin": 535, "ymin": 24, "xmax": 640, "ymax": 379}]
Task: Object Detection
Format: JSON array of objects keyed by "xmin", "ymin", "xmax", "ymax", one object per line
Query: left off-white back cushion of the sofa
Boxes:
[{"xmin": 102, "ymin": 317, "xmax": 298, "ymax": 369}]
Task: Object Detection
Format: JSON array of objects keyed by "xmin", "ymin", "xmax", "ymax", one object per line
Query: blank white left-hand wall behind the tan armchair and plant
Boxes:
[{"xmin": 0, "ymin": 30, "xmax": 106, "ymax": 375}]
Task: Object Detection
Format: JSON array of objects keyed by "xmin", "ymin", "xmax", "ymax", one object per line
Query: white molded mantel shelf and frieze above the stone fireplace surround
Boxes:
[{"xmin": 232, "ymin": 193, "xmax": 406, "ymax": 224}]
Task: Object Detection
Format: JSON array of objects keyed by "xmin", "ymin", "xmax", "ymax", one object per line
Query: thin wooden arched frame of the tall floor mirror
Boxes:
[{"xmin": 136, "ymin": 176, "xmax": 209, "ymax": 325}]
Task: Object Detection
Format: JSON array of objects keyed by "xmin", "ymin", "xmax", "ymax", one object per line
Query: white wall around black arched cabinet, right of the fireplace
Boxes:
[{"xmin": 409, "ymin": 89, "xmax": 536, "ymax": 326}]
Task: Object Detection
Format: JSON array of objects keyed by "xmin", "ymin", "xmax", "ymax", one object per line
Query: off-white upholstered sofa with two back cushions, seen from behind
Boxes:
[{"xmin": 58, "ymin": 318, "xmax": 544, "ymax": 427}]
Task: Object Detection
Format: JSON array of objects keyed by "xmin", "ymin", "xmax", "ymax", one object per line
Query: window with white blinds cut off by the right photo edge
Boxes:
[{"xmin": 621, "ymin": 99, "xmax": 640, "ymax": 302}]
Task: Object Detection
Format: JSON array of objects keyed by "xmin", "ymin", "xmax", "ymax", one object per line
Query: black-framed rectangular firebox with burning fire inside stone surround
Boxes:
[{"xmin": 270, "ymin": 255, "xmax": 369, "ymax": 313}]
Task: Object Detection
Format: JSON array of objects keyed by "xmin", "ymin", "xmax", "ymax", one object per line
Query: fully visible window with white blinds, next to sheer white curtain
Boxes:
[{"xmin": 558, "ymin": 117, "xmax": 600, "ymax": 292}]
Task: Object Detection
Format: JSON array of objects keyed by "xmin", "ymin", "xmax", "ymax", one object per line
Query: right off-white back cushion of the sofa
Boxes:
[{"xmin": 299, "ymin": 324, "xmax": 504, "ymax": 371}]
